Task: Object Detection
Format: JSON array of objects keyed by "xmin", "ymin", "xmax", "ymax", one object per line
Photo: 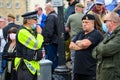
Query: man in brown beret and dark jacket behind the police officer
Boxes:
[{"xmin": 3, "ymin": 14, "xmax": 20, "ymax": 40}]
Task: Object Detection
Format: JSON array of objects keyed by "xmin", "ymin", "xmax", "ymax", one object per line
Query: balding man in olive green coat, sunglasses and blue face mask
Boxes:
[{"xmin": 93, "ymin": 12, "xmax": 120, "ymax": 80}]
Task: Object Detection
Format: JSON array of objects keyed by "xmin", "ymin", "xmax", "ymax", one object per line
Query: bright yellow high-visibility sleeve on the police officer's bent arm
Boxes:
[{"xmin": 17, "ymin": 29, "xmax": 44, "ymax": 50}]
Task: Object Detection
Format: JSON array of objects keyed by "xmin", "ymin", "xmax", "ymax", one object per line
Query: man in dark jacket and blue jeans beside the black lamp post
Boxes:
[{"xmin": 42, "ymin": 3, "xmax": 58, "ymax": 70}]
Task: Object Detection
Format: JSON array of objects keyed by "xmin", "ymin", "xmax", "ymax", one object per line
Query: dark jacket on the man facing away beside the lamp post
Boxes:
[{"xmin": 42, "ymin": 11, "xmax": 58, "ymax": 44}]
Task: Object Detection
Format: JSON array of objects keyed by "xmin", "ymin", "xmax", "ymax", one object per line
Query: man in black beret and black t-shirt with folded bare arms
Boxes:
[{"xmin": 69, "ymin": 14, "xmax": 102, "ymax": 80}]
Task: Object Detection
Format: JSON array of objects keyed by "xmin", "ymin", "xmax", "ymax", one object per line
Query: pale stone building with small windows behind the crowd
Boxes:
[{"xmin": 0, "ymin": 0, "xmax": 27, "ymax": 24}]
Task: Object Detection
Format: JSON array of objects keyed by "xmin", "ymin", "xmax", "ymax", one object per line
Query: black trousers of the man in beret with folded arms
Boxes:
[{"xmin": 73, "ymin": 73, "xmax": 96, "ymax": 80}]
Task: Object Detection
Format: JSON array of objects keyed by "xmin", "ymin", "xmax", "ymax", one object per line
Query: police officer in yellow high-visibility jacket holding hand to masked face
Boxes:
[{"xmin": 14, "ymin": 11, "xmax": 44, "ymax": 80}]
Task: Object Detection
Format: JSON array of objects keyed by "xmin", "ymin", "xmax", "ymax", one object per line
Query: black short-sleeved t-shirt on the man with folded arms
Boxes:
[{"xmin": 73, "ymin": 30, "xmax": 103, "ymax": 75}]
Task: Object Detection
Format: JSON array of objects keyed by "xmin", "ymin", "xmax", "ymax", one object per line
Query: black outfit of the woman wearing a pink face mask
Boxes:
[{"xmin": 2, "ymin": 41, "xmax": 17, "ymax": 80}]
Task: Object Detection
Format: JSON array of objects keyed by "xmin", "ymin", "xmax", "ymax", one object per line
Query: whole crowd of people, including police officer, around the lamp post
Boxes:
[{"xmin": 0, "ymin": 0, "xmax": 120, "ymax": 80}]
